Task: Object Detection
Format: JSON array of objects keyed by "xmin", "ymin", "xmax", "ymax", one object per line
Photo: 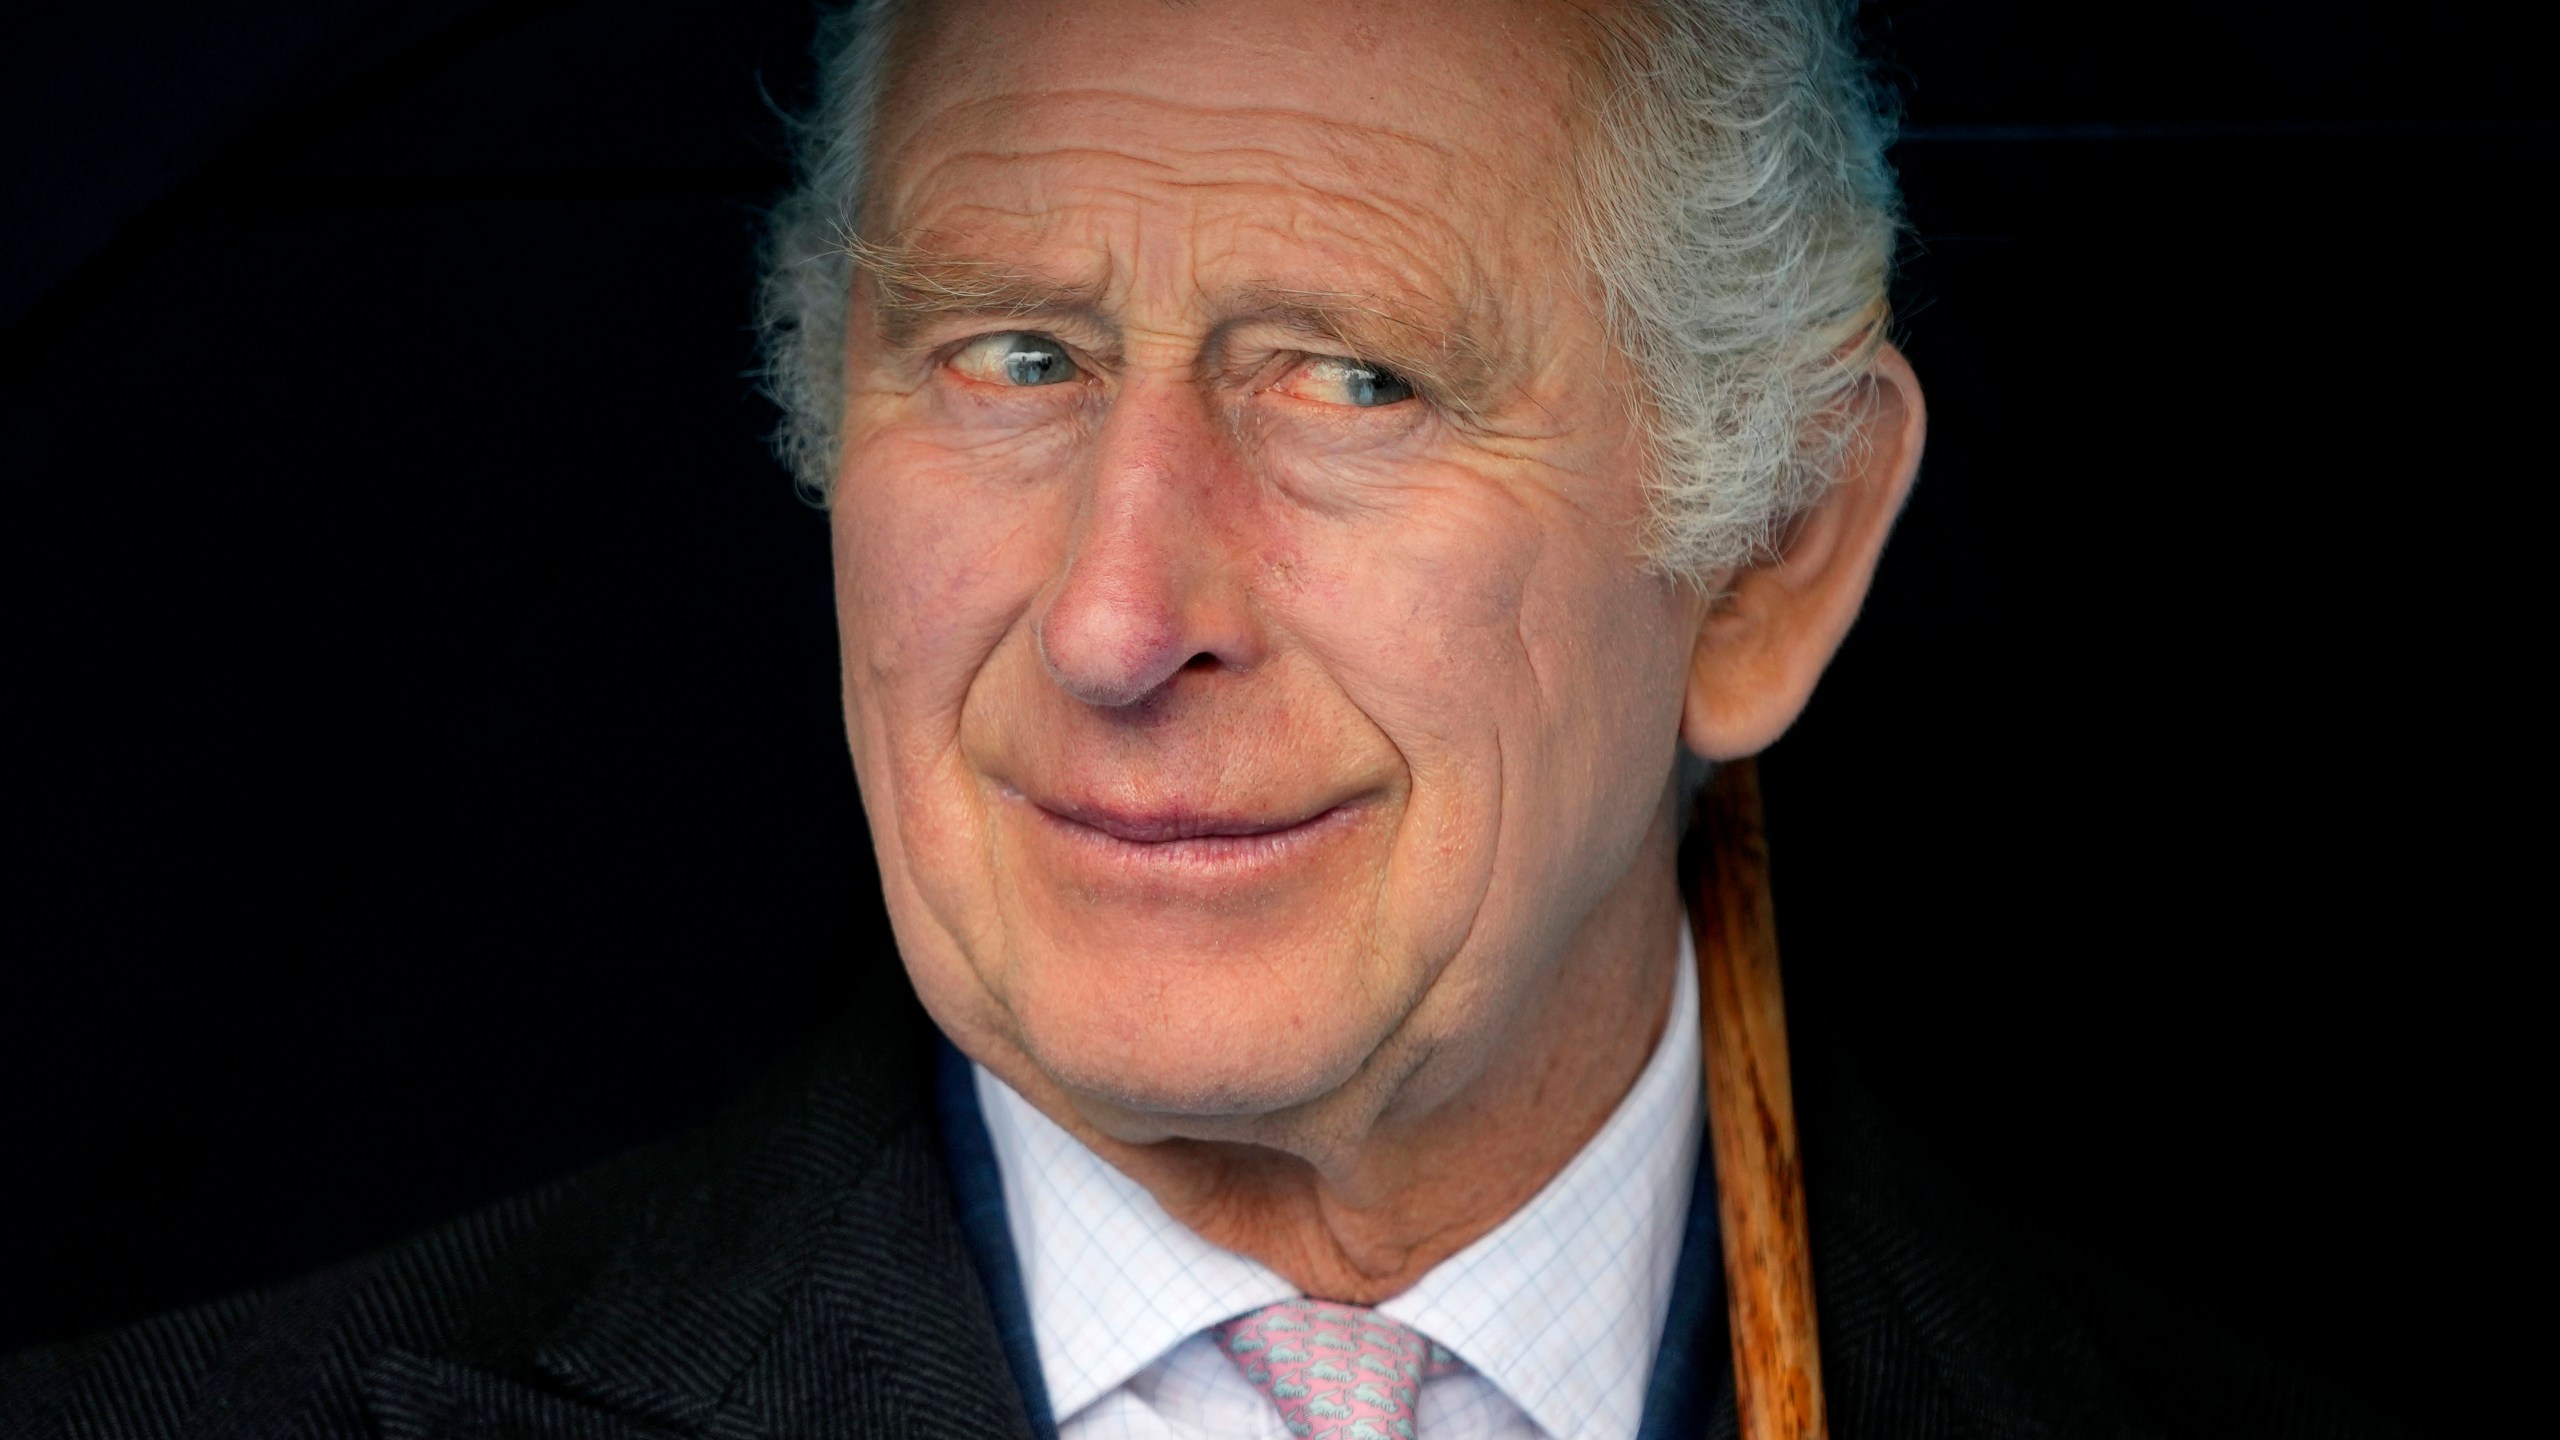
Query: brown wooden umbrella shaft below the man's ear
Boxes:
[{"xmin": 1690, "ymin": 761, "xmax": 1825, "ymax": 1440}]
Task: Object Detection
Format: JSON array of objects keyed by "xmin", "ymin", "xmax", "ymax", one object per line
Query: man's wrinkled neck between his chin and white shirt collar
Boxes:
[{"xmin": 1006, "ymin": 812, "xmax": 1684, "ymax": 1304}]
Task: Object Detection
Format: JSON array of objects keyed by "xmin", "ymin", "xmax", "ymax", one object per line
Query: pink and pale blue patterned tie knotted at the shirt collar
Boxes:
[{"xmin": 1213, "ymin": 1299, "xmax": 1459, "ymax": 1440}]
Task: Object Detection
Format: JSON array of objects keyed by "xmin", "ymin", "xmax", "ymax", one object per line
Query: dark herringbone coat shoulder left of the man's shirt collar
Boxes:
[{"xmin": 0, "ymin": 983, "xmax": 1006, "ymax": 1440}]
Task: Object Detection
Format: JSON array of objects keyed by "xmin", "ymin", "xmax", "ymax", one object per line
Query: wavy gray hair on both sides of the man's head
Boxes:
[{"xmin": 758, "ymin": 0, "xmax": 1900, "ymax": 584}]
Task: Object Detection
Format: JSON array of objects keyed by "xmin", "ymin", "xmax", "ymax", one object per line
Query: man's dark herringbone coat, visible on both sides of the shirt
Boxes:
[{"xmin": 0, "ymin": 958, "xmax": 2376, "ymax": 1440}]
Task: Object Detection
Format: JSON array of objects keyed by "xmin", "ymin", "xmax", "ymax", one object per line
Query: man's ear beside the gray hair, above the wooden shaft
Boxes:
[{"xmin": 1679, "ymin": 346, "xmax": 1928, "ymax": 761}]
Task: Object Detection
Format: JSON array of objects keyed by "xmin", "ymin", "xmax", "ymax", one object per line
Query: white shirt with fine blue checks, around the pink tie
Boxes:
[{"xmin": 978, "ymin": 925, "xmax": 1702, "ymax": 1440}]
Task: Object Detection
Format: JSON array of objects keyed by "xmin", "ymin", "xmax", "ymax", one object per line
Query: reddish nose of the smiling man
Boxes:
[{"xmin": 1034, "ymin": 382, "xmax": 1262, "ymax": 710}]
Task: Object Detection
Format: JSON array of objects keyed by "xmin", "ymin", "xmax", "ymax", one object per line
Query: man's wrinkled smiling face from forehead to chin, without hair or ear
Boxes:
[{"xmin": 835, "ymin": 0, "xmax": 1700, "ymax": 1117}]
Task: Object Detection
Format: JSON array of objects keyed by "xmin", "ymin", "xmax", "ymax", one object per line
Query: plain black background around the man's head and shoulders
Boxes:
[{"xmin": 0, "ymin": 0, "xmax": 2552, "ymax": 1435}]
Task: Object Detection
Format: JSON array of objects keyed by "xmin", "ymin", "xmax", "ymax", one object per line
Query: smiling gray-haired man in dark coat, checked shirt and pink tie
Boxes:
[{"xmin": 0, "ymin": 0, "xmax": 2396, "ymax": 1440}]
